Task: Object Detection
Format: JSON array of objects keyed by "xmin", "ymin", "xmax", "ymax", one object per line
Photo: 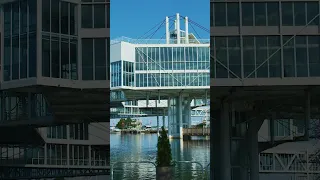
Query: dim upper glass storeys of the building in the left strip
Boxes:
[{"xmin": 1, "ymin": 0, "xmax": 110, "ymax": 82}]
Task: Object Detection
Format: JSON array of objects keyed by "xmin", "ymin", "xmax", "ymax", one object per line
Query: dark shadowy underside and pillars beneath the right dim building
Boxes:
[{"xmin": 210, "ymin": 85, "xmax": 320, "ymax": 180}]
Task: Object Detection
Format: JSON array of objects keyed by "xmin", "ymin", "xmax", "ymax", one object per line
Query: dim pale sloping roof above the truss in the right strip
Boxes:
[{"xmin": 262, "ymin": 139, "xmax": 320, "ymax": 154}]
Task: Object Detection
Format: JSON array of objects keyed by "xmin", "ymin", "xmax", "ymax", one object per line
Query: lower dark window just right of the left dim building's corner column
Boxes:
[{"xmin": 42, "ymin": 39, "xmax": 50, "ymax": 77}]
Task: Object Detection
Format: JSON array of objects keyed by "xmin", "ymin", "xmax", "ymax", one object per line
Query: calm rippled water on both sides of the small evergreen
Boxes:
[{"xmin": 110, "ymin": 134, "xmax": 210, "ymax": 180}]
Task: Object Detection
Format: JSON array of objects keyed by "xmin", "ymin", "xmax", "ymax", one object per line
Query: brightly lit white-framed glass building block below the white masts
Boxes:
[{"xmin": 111, "ymin": 42, "xmax": 210, "ymax": 88}]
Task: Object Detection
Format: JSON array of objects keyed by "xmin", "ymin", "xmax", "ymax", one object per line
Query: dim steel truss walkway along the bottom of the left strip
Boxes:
[{"xmin": 0, "ymin": 166, "xmax": 110, "ymax": 180}]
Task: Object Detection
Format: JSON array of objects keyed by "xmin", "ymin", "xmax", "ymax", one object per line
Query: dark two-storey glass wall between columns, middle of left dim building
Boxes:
[{"xmin": 42, "ymin": 0, "xmax": 78, "ymax": 80}]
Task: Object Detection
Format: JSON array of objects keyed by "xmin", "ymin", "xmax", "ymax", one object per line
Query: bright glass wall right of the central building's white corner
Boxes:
[{"xmin": 135, "ymin": 47, "xmax": 210, "ymax": 87}]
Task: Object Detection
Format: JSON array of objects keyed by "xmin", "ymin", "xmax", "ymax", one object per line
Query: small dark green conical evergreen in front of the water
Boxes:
[{"xmin": 157, "ymin": 126, "xmax": 172, "ymax": 167}]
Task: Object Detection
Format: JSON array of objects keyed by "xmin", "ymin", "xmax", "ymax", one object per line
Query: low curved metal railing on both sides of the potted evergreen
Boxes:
[{"xmin": 110, "ymin": 161, "xmax": 210, "ymax": 180}]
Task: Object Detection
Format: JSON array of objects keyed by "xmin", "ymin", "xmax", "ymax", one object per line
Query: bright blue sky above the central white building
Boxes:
[{"xmin": 110, "ymin": 0, "xmax": 210, "ymax": 39}]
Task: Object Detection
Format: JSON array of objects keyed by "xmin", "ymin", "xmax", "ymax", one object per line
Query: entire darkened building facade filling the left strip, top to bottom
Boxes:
[{"xmin": 0, "ymin": 0, "xmax": 110, "ymax": 179}]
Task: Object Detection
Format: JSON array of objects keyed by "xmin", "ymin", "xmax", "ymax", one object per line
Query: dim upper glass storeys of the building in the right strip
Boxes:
[{"xmin": 210, "ymin": 0, "xmax": 320, "ymax": 78}]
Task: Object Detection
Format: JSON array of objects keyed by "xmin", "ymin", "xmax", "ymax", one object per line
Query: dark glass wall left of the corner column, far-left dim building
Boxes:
[{"xmin": 2, "ymin": 0, "xmax": 37, "ymax": 81}]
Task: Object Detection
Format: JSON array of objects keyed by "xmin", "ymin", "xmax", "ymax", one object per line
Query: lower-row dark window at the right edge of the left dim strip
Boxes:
[{"xmin": 94, "ymin": 39, "xmax": 107, "ymax": 80}]
